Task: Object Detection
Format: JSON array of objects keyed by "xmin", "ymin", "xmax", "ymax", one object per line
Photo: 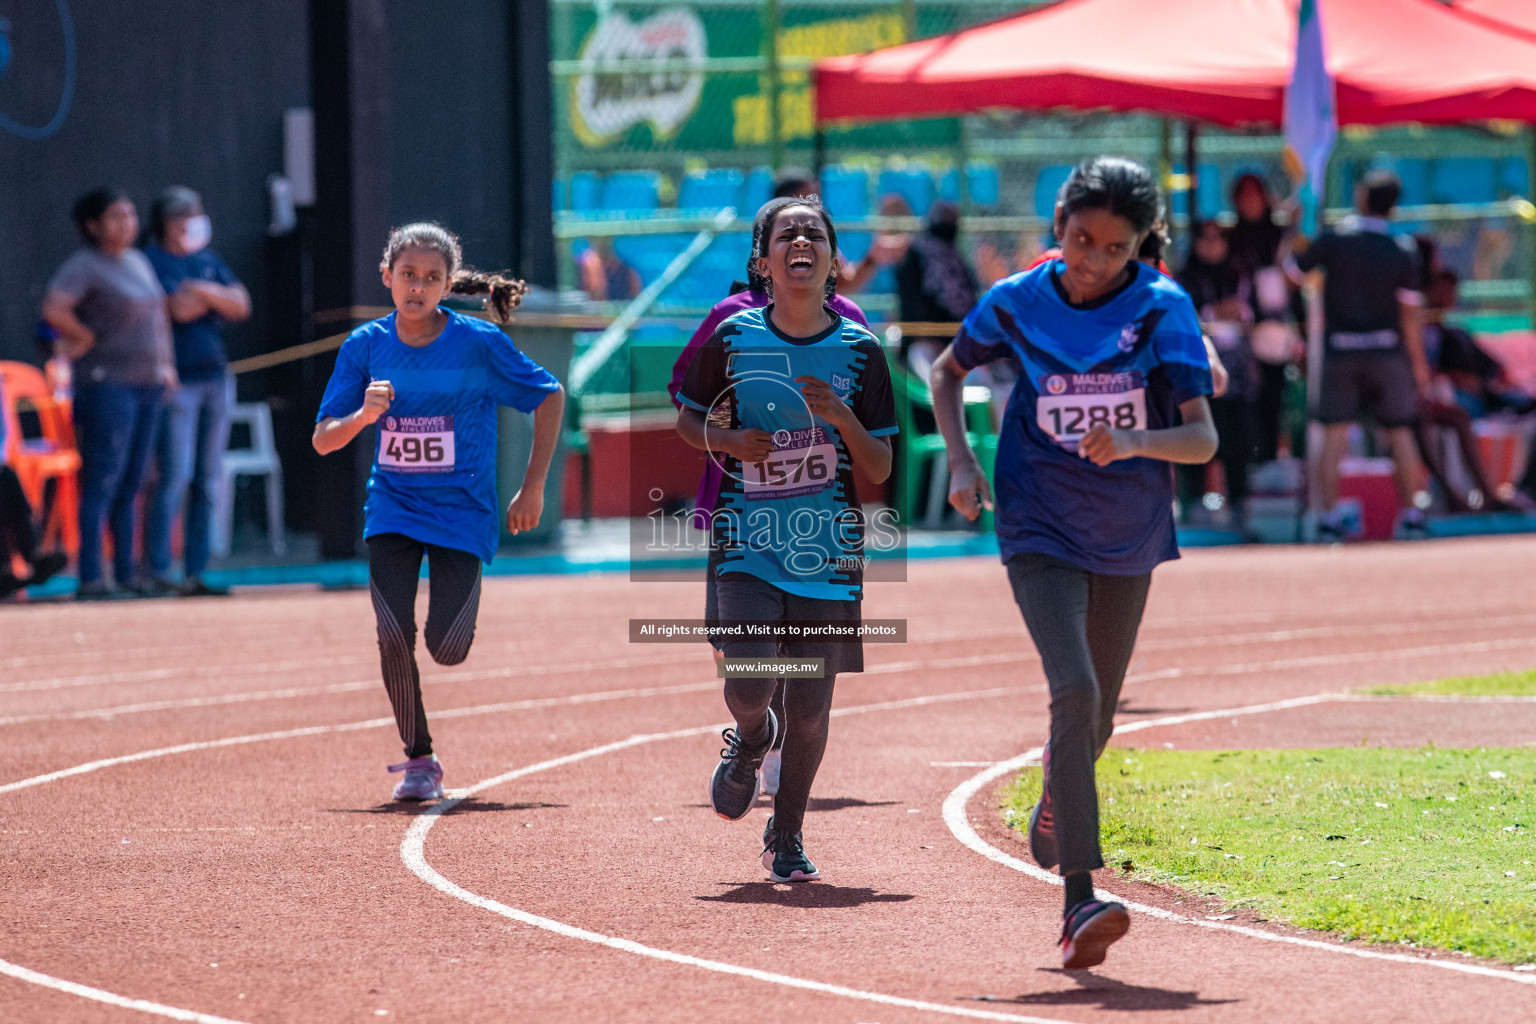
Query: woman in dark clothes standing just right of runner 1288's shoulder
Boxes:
[{"xmin": 1177, "ymin": 221, "xmax": 1260, "ymax": 534}]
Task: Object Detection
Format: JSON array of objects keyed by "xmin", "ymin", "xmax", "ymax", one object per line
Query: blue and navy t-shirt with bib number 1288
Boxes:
[{"xmin": 954, "ymin": 259, "xmax": 1212, "ymax": 576}]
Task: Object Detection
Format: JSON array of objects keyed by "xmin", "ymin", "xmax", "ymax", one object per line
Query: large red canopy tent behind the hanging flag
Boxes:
[{"xmin": 816, "ymin": 0, "xmax": 1536, "ymax": 127}]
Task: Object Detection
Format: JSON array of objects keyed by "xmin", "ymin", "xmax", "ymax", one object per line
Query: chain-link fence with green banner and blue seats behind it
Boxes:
[{"xmin": 551, "ymin": 0, "xmax": 1536, "ymax": 405}]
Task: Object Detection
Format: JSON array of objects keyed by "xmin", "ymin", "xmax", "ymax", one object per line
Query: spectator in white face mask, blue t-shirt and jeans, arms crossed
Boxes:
[{"xmin": 144, "ymin": 186, "xmax": 248, "ymax": 596}]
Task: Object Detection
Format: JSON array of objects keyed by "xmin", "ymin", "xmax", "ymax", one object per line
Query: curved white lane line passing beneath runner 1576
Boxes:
[{"xmin": 399, "ymin": 686, "xmax": 1069, "ymax": 1024}]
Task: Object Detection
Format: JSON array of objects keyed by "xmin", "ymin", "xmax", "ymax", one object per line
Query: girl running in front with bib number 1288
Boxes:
[{"xmin": 932, "ymin": 157, "xmax": 1217, "ymax": 969}]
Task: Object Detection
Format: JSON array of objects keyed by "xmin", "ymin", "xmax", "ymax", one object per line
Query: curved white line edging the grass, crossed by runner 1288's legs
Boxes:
[{"xmin": 943, "ymin": 694, "xmax": 1536, "ymax": 984}]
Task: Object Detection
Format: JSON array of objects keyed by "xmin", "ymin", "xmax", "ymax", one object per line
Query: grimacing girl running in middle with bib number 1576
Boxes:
[{"xmin": 677, "ymin": 198, "xmax": 895, "ymax": 881}]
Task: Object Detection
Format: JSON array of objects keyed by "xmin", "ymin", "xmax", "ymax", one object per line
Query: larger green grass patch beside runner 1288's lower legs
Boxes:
[{"xmin": 1003, "ymin": 748, "xmax": 1536, "ymax": 964}]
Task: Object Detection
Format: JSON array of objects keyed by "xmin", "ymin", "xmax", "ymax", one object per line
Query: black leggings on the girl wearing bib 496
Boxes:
[{"xmin": 369, "ymin": 533, "xmax": 481, "ymax": 757}]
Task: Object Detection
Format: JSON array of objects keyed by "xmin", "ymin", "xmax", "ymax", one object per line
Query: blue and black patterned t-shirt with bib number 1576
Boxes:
[{"xmin": 677, "ymin": 306, "xmax": 895, "ymax": 600}]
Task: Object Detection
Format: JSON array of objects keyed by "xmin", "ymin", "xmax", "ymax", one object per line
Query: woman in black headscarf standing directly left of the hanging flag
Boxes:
[{"xmin": 1227, "ymin": 173, "xmax": 1301, "ymax": 462}]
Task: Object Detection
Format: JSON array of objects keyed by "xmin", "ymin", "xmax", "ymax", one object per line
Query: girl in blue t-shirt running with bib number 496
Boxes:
[{"xmin": 315, "ymin": 224, "xmax": 565, "ymax": 800}]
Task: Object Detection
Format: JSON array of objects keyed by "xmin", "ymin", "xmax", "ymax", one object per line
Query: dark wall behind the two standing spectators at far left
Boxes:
[{"xmin": 0, "ymin": 0, "xmax": 309, "ymax": 361}]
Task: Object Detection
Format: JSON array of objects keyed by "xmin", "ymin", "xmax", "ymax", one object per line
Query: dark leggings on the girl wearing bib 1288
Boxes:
[{"xmin": 1008, "ymin": 554, "xmax": 1152, "ymax": 875}]
